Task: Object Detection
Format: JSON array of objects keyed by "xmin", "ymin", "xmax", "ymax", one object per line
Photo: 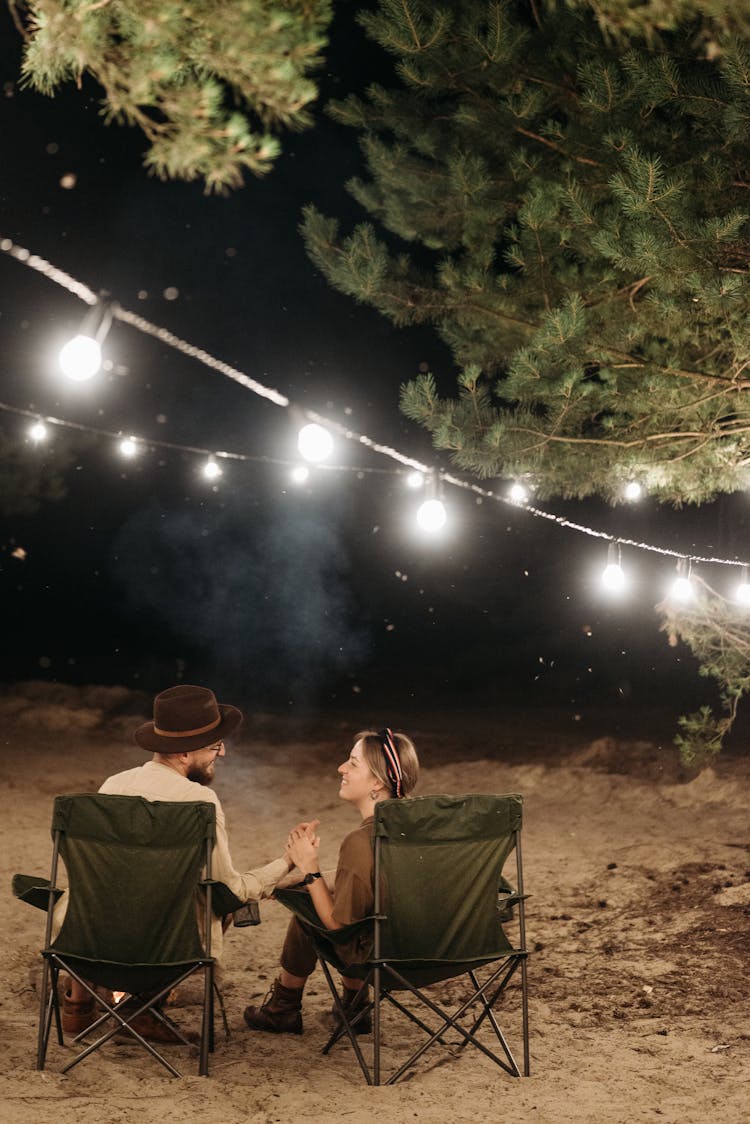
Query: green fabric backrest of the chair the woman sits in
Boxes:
[{"xmin": 374, "ymin": 795, "xmax": 523, "ymax": 963}]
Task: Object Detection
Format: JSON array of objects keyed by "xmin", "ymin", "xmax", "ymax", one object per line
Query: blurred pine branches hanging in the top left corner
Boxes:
[{"xmin": 9, "ymin": 0, "xmax": 332, "ymax": 192}]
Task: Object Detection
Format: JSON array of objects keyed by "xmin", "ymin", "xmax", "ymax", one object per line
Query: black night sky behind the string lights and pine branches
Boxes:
[{"xmin": 0, "ymin": 4, "xmax": 748, "ymax": 724}]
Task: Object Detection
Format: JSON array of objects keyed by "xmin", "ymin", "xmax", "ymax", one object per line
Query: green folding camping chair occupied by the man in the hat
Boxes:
[{"xmin": 13, "ymin": 794, "xmax": 222, "ymax": 1077}]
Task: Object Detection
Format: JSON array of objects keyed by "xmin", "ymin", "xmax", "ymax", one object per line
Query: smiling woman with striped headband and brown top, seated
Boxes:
[{"xmin": 244, "ymin": 729, "xmax": 419, "ymax": 1034}]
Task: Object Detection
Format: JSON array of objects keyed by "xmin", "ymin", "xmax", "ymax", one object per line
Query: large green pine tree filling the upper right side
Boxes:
[{"xmin": 302, "ymin": 0, "xmax": 750, "ymax": 763}]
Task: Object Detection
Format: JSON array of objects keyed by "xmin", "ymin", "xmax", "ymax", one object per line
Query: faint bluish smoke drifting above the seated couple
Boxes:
[{"xmin": 112, "ymin": 497, "xmax": 368, "ymax": 701}]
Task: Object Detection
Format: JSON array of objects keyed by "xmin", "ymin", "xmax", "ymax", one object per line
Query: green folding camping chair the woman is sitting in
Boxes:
[{"xmin": 275, "ymin": 795, "xmax": 530, "ymax": 1085}]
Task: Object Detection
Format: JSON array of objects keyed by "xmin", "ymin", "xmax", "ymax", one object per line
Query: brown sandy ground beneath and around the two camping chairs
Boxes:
[{"xmin": 0, "ymin": 686, "xmax": 750, "ymax": 1124}]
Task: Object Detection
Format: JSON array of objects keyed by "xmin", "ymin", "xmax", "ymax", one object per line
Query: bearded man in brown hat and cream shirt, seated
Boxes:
[{"xmin": 62, "ymin": 683, "xmax": 292, "ymax": 1041}]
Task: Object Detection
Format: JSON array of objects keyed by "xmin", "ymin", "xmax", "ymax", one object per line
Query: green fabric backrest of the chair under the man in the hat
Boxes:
[{"xmin": 51, "ymin": 794, "xmax": 216, "ymax": 980}]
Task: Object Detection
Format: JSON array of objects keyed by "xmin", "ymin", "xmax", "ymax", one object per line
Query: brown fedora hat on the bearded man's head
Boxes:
[{"xmin": 133, "ymin": 683, "xmax": 242, "ymax": 753}]
